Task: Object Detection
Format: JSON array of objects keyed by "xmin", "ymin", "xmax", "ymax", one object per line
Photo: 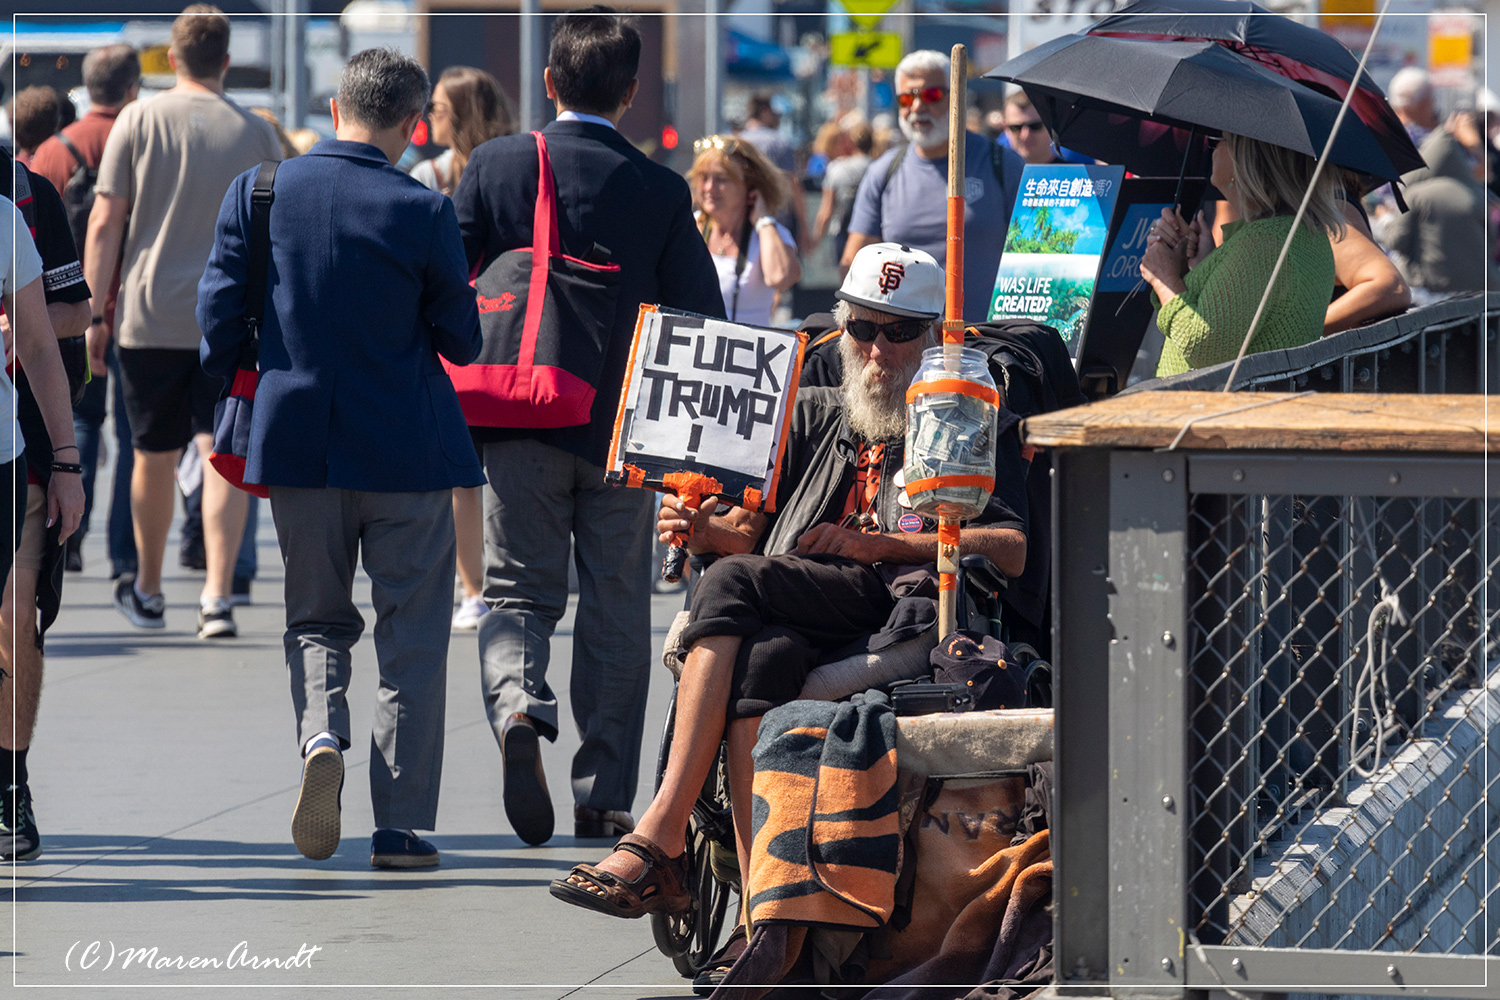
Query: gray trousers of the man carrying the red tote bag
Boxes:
[{"xmin": 479, "ymin": 441, "xmax": 656, "ymax": 810}]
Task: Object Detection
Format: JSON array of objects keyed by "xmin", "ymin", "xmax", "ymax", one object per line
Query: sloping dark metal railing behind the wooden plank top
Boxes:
[{"xmin": 1125, "ymin": 292, "xmax": 1500, "ymax": 393}]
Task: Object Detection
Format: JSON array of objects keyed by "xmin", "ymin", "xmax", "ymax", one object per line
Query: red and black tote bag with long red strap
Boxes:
[{"xmin": 443, "ymin": 132, "xmax": 620, "ymax": 427}]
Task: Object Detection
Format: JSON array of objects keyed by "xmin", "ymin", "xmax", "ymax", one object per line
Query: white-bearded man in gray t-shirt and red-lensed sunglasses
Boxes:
[{"xmin": 840, "ymin": 49, "xmax": 1025, "ymax": 319}]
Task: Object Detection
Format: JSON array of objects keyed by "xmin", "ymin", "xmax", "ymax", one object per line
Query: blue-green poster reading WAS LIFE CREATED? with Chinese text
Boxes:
[{"xmin": 989, "ymin": 163, "xmax": 1125, "ymax": 354}]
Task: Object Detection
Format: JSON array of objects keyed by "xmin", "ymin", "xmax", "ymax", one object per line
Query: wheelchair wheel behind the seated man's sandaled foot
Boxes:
[{"xmin": 651, "ymin": 694, "xmax": 735, "ymax": 979}]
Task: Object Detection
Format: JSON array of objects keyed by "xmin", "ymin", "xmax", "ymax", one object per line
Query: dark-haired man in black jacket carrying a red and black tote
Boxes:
[{"xmin": 453, "ymin": 6, "xmax": 725, "ymax": 844}]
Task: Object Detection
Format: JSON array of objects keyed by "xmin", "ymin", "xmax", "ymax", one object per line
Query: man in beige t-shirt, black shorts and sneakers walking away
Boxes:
[{"xmin": 84, "ymin": 3, "xmax": 282, "ymax": 639}]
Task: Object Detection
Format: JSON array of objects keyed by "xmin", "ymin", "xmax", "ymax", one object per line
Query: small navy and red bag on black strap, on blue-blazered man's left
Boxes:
[{"xmin": 209, "ymin": 160, "xmax": 278, "ymax": 496}]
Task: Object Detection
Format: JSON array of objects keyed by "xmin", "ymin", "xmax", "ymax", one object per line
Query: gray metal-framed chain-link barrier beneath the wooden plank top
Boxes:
[{"xmin": 1053, "ymin": 395, "xmax": 1500, "ymax": 997}]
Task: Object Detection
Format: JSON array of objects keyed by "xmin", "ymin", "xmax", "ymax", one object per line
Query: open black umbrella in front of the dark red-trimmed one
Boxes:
[{"xmin": 986, "ymin": 34, "xmax": 1401, "ymax": 180}]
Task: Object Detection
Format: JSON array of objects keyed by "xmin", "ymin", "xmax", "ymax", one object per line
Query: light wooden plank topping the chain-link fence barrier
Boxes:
[{"xmin": 1022, "ymin": 391, "xmax": 1487, "ymax": 454}]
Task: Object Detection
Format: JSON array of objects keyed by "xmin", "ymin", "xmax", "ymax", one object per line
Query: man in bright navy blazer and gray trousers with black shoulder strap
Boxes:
[{"xmin": 198, "ymin": 49, "xmax": 485, "ymax": 868}]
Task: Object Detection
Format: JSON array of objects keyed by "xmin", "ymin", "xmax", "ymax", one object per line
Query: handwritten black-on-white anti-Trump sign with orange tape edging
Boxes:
[{"xmin": 609, "ymin": 306, "xmax": 807, "ymax": 508}]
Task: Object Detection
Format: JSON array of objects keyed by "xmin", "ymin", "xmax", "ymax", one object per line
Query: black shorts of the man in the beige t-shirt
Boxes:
[{"xmin": 119, "ymin": 348, "xmax": 224, "ymax": 451}]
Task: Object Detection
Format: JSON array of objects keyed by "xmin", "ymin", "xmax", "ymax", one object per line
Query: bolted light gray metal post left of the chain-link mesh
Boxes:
[{"xmin": 1109, "ymin": 451, "xmax": 1190, "ymax": 999}]
